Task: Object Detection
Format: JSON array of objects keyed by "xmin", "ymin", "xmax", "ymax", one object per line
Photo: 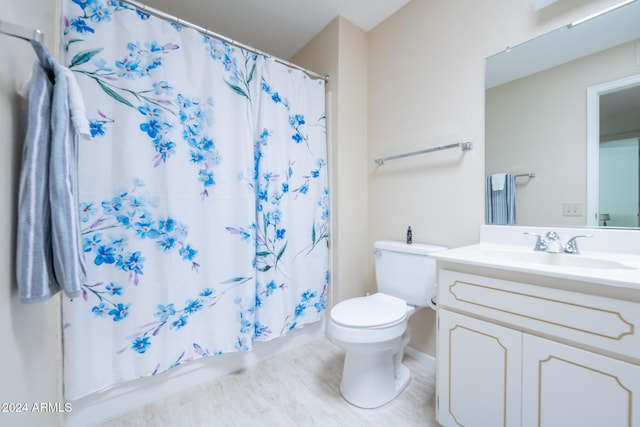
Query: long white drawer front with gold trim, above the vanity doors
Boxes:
[{"xmin": 438, "ymin": 269, "xmax": 640, "ymax": 363}]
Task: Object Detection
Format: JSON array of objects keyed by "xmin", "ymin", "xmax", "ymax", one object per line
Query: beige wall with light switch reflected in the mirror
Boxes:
[{"xmin": 486, "ymin": 40, "xmax": 640, "ymax": 226}]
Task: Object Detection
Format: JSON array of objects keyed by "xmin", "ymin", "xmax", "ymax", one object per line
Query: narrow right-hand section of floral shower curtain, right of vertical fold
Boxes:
[{"xmin": 255, "ymin": 60, "xmax": 329, "ymax": 339}]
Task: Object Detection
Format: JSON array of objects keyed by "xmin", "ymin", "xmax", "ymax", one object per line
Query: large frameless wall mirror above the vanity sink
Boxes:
[{"xmin": 485, "ymin": 0, "xmax": 640, "ymax": 227}]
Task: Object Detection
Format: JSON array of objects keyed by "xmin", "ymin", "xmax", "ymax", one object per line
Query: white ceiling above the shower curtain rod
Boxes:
[{"xmin": 140, "ymin": 0, "xmax": 409, "ymax": 59}]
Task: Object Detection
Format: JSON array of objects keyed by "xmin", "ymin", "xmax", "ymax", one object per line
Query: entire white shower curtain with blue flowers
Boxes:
[{"xmin": 63, "ymin": 0, "xmax": 329, "ymax": 400}]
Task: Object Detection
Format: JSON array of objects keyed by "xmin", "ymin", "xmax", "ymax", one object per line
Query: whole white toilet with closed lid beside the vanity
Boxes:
[{"xmin": 329, "ymin": 241, "xmax": 447, "ymax": 408}]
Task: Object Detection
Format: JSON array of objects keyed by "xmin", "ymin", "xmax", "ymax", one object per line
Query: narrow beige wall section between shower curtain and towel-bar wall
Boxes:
[{"xmin": 292, "ymin": 17, "xmax": 371, "ymax": 303}]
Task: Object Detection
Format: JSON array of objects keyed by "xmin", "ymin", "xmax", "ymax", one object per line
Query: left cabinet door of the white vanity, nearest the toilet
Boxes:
[{"xmin": 437, "ymin": 309, "xmax": 522, "ymax": 427}]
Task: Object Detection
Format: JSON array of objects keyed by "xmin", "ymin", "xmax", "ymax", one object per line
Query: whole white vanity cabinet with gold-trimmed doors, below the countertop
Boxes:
[{"xmin": 437, "ymin": 269, "xmax": 640, "ymax": 427}]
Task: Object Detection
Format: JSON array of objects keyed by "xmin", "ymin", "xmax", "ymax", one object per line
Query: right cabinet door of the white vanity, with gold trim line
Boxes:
[{"xmin": 522, "ymin": 334, "xmax": 640, "ymax": 427}]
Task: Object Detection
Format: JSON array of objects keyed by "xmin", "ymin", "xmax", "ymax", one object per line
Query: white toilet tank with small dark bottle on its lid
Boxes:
[{"xmin": 373, "ymin": 241, "xmax": 447, "ymax": 307}]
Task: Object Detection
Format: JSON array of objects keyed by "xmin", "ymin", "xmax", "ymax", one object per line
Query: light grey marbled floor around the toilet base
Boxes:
[{"xmin": 100, "ymin": 340, "xmax": 438, "ymax": 427}]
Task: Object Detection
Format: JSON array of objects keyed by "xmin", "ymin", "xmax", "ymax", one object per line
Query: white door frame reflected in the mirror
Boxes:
[{"xmin": 587, "ymin": 74, "xmax": 640, "ymax": 226}]
